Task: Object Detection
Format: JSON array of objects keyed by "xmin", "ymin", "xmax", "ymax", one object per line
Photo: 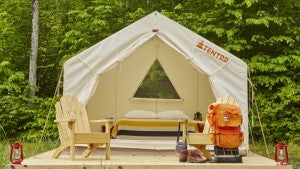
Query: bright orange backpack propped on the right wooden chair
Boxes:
[{"xmin": 207, "ymin": 103, "xmax": 244, "ymax": 148}]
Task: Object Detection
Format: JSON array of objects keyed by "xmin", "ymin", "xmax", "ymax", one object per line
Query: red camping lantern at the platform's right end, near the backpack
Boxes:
[{"xmin": 274, "ymin": 142, "xmax": 289, "ymax": 166}]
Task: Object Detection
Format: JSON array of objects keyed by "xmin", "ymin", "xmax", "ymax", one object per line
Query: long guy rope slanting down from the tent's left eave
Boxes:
[{"xmin": 34, "ymin": 69, "xmax": 63, "ymax": 154}]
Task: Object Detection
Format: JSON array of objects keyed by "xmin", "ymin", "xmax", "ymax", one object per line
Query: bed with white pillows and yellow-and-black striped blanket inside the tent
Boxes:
[{"xmin": 112, "ymin": 110, "xmax": 198, "ymax": 141}]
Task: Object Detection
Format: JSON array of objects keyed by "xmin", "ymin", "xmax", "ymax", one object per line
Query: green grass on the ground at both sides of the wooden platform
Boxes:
[{"xmin": 0, "ymin": 142, "xmax": 300, "ymax": 169}]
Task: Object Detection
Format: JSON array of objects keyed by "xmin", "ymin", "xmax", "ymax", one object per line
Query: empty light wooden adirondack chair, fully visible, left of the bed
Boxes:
[{"xmin": 53, "ymin": 96, "xmax": 113, "ymax": 160}]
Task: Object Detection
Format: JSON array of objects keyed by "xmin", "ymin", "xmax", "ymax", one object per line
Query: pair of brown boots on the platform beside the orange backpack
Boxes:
[{"xmin": 179, "ymin": 150, "xmax": 206, "ymax": 163}]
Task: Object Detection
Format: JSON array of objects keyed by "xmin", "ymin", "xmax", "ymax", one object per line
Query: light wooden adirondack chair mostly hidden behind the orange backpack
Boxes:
[{"xmin": 186, "ymin": 96, "xmax": 239, "ymax": 160}]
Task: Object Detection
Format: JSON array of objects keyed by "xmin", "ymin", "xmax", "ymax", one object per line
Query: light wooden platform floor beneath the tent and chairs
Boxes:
[{"xmin": 7, "ymin": 147, "xmax": 292, "ymax": 169}]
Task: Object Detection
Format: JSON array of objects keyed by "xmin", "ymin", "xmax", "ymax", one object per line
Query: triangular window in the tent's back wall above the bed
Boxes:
[{"xmin": 134, "ymin": 60, "xmax": 180, "ymax": 99}]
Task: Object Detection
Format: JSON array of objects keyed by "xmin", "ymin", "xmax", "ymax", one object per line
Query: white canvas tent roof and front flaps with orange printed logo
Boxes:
[{"xmin": 64, "ymin": 11, "xmax": 248, "ymax": 113}]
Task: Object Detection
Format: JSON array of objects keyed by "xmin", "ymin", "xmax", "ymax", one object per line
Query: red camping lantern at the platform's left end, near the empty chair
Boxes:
[{"xmin": 10, "ymin": 141, "xmax": 24, "ymax": 164}]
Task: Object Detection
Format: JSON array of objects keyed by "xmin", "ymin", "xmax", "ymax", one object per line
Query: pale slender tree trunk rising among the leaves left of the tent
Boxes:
[{"xmin": 29, "ymin": 0, "xmax": 39, "ymax": 96}]
